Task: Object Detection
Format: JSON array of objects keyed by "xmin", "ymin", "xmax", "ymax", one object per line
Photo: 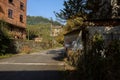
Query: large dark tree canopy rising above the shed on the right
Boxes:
[{"xmin": 55, "ymin": 0, "xmax": 112, "ymax": 20}]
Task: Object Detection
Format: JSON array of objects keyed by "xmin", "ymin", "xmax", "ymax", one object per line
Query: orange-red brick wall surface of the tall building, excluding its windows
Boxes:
[{"xmin": 0, "ymin": 0, "xmax": 26, "ymax": 28}]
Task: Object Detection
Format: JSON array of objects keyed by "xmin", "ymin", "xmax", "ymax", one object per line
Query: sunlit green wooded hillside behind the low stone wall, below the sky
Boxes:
[{"xmin": 27, "ymin": 16, "xmax": 62, "ymax": 49}]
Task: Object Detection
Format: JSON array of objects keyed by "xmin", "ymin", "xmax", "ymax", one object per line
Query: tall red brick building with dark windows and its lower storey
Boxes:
[{"xmin": 0, "ymin": 0, "xmax": 27, "ymax": 39}]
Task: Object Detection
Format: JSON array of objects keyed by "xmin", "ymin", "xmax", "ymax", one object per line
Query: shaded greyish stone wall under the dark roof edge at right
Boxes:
[{"xmin": 88, "ymin": 26, "xmax": 120, "ymax": 40}]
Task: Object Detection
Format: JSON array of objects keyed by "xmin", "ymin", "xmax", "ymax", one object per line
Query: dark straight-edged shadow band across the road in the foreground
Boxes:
[{"xmin": 0, "ymin": 71, "xmax": 64, "ymax": 80}]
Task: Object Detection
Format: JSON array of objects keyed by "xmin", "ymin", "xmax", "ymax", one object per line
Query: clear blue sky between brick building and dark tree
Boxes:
[{"xmin": 27, "ymin": 0, "xmax": 64, "ymax": 20}]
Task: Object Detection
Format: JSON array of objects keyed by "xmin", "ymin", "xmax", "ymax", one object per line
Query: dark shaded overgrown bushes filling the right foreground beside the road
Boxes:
[{"xmin": 64, "ymin": 33, "xmax": 120, "ymax": 80}]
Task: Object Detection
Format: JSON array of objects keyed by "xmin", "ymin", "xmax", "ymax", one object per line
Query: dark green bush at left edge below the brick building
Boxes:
[{"xmin": 0, "ymin": 21, "xmax": 16, "ymax": 55}]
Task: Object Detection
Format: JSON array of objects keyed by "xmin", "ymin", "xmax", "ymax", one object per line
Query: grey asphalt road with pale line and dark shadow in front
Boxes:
[{"xmin": 0, "ymin": 49, "xmax": 64, "ymax": 80}]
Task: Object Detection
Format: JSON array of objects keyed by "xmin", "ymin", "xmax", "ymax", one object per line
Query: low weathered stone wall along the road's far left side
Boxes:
[{"xmin": 14, "ymin": 40, "xmax": 50, "ymax": 53}]
